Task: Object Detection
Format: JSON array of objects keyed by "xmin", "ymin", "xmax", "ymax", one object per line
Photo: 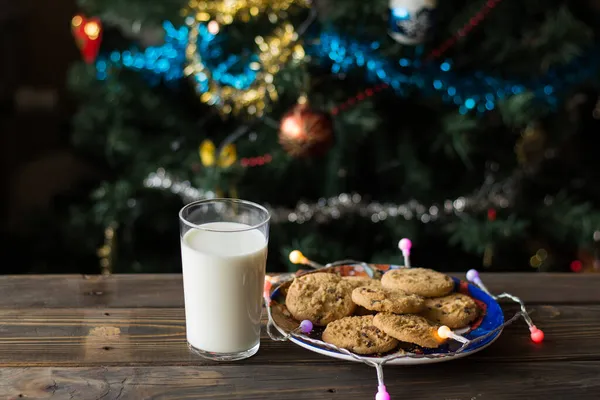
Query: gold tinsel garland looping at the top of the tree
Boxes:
[{"xmin": 182, "ymin": 0, "xmax": 309, "ymax": 116}]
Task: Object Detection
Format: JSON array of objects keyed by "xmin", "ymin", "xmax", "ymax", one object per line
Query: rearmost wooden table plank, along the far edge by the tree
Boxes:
[{"xmin": 0, "ymin": 273, "xmax": 600, "ymax": 309}]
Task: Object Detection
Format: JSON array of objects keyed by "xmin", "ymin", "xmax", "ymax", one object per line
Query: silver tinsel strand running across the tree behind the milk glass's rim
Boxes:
[{"xmin": 144, "ymin": 168, "xmax": 514, "ymax": 224}]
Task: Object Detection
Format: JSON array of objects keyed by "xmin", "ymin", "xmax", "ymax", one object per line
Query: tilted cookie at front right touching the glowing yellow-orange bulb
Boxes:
[{"xmin": 373, "ymin": 313, "xmax": 443, "ymax": 348}]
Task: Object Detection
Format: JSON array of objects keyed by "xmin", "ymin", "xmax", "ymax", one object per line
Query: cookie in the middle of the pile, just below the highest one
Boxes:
[{"xmin": 352, "ymin": 286, "xmax": 425, "ymax": 314}]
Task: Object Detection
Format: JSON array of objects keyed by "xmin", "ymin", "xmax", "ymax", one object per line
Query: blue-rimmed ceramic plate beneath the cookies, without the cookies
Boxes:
[{"xmin": 270, "ymin": 264, "xmax": 504, "ymax": 365}]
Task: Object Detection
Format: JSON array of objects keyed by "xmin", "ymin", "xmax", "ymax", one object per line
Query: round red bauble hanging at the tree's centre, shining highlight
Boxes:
[{"xmin": 279, "ymin": 103, "xmax": 333, "ymax": 157}]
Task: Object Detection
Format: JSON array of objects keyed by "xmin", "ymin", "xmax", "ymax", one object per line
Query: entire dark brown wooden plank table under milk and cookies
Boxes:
[{"xmin": 0, "ymin": 274, "xmax": 600, "ymax": 400}]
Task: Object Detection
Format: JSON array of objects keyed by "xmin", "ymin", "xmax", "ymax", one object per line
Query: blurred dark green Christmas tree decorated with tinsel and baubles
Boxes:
[{"xmin": 38, "ymin": 0, "xmax": 600, "ymax": 272}]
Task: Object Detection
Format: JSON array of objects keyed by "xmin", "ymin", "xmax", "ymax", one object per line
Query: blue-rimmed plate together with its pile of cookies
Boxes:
[{"xmin": 265, "ymin": 261, "xmax": 505, "ymax": 365}]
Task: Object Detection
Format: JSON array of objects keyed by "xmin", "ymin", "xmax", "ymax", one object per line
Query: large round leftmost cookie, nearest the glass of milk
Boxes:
[{"xmin": 285, "ymin": 272, "xmax": 356, "ymax": 326}]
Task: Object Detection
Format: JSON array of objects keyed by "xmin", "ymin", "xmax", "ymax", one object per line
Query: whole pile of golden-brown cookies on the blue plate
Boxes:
[{"xmin": 286, "ymin": 268, "xmax": 479, "ymax": 355}]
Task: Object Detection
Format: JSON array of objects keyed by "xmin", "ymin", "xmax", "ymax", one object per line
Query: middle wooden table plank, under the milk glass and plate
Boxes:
[{"xmin": 0, "ymin": 305, "xmax": 600, "ymax": 367}]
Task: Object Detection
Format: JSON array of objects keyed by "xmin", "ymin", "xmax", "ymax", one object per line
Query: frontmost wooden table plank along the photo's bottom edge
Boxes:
[{"xmin": 0, "ymin": 359, "xmax": 600, "ymax": 400}]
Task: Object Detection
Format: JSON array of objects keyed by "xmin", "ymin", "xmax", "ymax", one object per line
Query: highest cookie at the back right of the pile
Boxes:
[{"xmin": 381, "ymin": 268, "xmax": 454, "ymax": 297}]
